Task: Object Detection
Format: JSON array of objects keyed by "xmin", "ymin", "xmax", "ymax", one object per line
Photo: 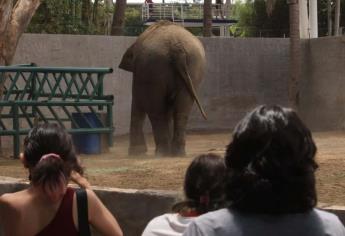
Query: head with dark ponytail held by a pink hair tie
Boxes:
[{"xmin": 22, "ymin": 123, "xmax": 82, "ymax": 199}]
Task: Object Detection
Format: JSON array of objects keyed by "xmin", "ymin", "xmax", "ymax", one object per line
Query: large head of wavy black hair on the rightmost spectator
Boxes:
[{"xmin": 225, "ymin": 106, "xmax": 317, "ymax": 214}]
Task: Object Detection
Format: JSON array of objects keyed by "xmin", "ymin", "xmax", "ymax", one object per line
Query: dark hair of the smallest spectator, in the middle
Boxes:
[{"xmin": 173, "ymin": 153, "xmax": 226, "ymax": 214}]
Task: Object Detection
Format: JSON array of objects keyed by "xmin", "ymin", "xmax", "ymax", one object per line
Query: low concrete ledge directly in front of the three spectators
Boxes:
[{"xmin": 0, "ymin": 177, "xmax": 345, "ymax": 236}]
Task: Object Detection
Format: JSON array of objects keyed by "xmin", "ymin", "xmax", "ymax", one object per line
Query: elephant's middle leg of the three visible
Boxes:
[{"xmin": 148, "ymin": 113, "xmax": 172, "ymax": 156}]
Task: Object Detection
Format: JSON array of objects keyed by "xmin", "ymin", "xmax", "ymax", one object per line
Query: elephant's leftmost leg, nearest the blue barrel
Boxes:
[{"xmin": 128, "ymin": 98, "xmax": 147, "ymax": 155}]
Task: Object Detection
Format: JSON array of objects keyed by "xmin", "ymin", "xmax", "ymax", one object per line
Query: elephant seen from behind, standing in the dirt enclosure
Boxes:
[{"xmin": 119, "ymin": 21, "xmax": 206, "ymax": 156}]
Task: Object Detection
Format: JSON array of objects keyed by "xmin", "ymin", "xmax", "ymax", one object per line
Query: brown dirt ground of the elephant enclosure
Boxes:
[{"xmin": 0, "ymin": 132, "xmax": 345, "ymax": 205}]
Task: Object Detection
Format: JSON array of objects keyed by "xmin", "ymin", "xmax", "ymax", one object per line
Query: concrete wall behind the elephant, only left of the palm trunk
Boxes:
[{"xmin": 14, "ymin": 34, "xmax": 289, "ymax": 134}]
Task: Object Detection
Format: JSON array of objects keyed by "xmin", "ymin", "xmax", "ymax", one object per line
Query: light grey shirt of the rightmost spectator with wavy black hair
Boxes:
[{"xmin": 183, "ymin": 209, "xmax": 345, "ymax": 236}]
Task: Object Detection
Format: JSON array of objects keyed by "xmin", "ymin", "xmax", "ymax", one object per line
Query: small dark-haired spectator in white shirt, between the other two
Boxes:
[{"xmin": 142, "ymin": 153, "xmax": 225, "ymax": 236}]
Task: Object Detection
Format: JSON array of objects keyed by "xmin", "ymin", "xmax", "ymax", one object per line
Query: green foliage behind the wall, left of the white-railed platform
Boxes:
[{"xmin": 27, "ymin": 0, "xmax": 143, "ymax": 36}]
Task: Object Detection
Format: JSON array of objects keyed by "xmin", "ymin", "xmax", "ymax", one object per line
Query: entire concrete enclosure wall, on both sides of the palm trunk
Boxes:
[{"xmin": 14, "ymin": 34, "xmax": 345, "ymax": 135}]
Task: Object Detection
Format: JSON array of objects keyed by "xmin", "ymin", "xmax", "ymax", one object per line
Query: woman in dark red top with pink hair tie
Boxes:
[{"xmin": 0, "ymin": 124, "xmax": 122, "ymax": 236}]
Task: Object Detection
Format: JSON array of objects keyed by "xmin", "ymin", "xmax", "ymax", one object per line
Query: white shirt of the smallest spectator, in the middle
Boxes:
[{"xmin": 142, "ymin": 213, "xmax": 195, "ymax": 236}]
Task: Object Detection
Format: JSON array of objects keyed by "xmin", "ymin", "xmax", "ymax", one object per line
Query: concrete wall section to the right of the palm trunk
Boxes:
[{"xmin": 300, "ymin": 37, "xmax": 345, "ymax": 130}]
